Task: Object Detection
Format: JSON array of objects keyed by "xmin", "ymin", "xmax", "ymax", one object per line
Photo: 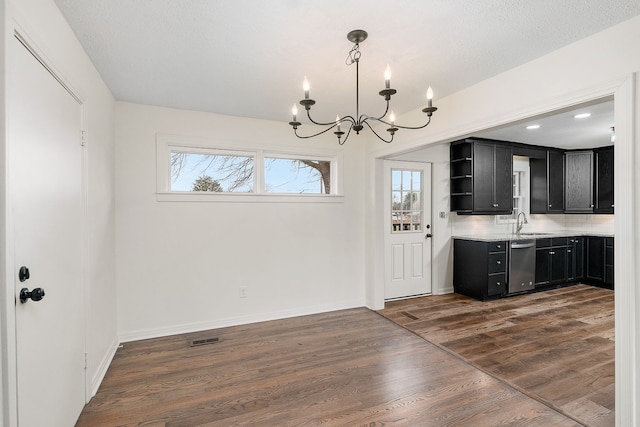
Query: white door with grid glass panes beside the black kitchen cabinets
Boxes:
[{"xmin": 384, "ymin": 161, "xmax": 432, "ymax": 299}]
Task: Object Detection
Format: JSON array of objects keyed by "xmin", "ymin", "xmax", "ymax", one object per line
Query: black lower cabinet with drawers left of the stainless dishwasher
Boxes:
[{"xmin": 453, "ymin": 239, "xmax": 508, "ymax": 301}]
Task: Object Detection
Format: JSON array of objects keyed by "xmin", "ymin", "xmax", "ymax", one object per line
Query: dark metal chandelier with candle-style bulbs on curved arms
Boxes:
[{"xmin": 289, "ymin": 30, "xmax": 437, "ymax": 145}]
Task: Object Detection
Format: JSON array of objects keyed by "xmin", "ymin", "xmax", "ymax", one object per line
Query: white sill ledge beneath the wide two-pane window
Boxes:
[{"xmin": 156, "ymin": 192, "xmax": 344, "ymax": 203}]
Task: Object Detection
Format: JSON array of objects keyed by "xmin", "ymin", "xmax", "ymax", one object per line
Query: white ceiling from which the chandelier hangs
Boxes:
[{"xmin": 55, "ymin": 0, "xmax": 640, "ymax": 146}]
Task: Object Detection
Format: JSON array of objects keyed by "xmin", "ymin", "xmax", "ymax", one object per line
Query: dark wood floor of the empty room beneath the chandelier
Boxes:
[{"xmin": 77, "ymin": 308, "xmax": 579, "ymax": 427}]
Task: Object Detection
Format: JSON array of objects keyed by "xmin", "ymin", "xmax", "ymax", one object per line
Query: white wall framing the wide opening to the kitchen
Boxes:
[{"xmin": 366, "ymin": 17, "xmax": 640, "ymax": 425}]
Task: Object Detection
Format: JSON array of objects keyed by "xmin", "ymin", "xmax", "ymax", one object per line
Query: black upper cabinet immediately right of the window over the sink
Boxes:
[{"xmin": 529, "ymin": 149, "xmax": 565, "ymax": 214}]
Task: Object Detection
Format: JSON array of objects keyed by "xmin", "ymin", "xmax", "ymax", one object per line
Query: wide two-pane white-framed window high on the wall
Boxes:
[{"xmin": 156, "ymin": 135, "xmax": 341, "ymax": 201}]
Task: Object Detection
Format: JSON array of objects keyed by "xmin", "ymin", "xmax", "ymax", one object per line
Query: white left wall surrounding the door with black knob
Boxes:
[{"xmin": 0, "ymin": 0, "xmax": 117, "ymax": 425}]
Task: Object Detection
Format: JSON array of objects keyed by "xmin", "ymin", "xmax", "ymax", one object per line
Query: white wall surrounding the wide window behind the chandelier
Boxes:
[{"xmin": 116, "ymin": 102, "xmax": 365, "ymax": 341}]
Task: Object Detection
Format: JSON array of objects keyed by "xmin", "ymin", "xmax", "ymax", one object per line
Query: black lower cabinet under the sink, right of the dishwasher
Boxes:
[{"xmin": 536, "ymin": 237, "xmax": 567, "ymax": 287}]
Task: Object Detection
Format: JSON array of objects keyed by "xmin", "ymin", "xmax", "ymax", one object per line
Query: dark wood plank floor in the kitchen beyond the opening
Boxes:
[{"xmin": 380, "ymin": 285, "xmax": 615, "ymax": 426}]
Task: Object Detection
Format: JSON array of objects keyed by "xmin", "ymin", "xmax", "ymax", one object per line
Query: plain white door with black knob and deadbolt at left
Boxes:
[{"xmin": 8, "ymin": 34, "xmax": 85, "ymax": 427}]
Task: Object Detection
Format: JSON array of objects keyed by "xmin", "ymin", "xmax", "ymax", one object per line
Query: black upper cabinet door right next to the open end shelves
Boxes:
[{"xmin": 473, "ymin": 143, "xmax": 495, "ymax": 212}]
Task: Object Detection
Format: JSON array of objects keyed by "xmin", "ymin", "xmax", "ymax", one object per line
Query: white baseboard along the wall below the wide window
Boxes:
[{"xmin": 120, "ymin": 301, "xmax": 363, "ymax": 343}]
